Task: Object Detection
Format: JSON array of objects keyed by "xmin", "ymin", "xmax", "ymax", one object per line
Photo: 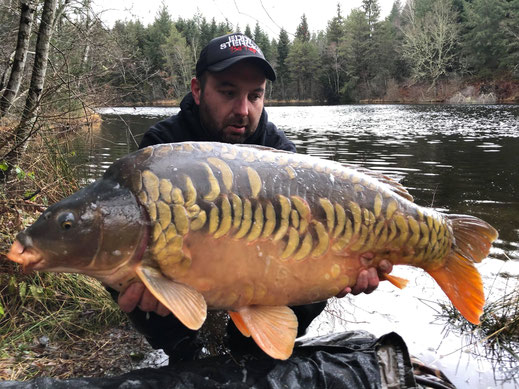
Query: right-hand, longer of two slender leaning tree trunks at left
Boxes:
[{"xmin": 0, "ymin": 0, "xmax": 57, "ymax": 180}]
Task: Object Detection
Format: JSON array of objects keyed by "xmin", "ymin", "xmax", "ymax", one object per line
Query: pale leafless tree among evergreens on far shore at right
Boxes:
[{"xmin": 402, "ymin": 0, "xmax": 459, "ymax": 88}]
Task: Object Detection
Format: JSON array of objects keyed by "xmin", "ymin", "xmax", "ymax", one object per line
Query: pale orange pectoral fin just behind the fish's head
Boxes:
[{"xmin": 136, "ymin": 266, "xmax": 207, "ymax": 330}]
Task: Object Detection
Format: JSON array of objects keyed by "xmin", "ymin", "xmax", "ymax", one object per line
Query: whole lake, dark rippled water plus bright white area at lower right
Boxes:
[{"xmin": 91, "ymin": 105, "xmax": 519, "ymax": 388}]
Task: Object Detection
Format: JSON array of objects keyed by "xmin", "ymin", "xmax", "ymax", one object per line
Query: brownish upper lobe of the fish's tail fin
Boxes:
[{"xmin": 447, "ymin": 215, "xmax": 498, "ymax": 262}]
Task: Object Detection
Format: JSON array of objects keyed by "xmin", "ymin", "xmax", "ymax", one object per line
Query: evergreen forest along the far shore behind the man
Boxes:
[{"xmin": 0, "ymin": 0, "xmax": 519, "ymax": 116}]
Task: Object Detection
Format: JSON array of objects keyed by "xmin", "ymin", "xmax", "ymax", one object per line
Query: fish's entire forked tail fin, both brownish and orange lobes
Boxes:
[{"xmin": 427, "ymin": 215, "xmax": 498, "ymax": 324}]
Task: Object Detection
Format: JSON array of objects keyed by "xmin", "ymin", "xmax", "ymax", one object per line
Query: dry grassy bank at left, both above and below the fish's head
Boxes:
[{"xmin": 0, "ymin": 116, "xmax": 149, "ymax": 380}]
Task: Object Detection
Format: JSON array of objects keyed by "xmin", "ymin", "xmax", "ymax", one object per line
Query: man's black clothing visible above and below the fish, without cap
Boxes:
[{"xmin": 123, "ymin": 93, "xmax": 326, "ymax": 362}]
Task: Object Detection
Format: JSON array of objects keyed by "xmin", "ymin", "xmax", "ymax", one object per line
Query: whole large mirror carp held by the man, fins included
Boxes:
[{"xmin": 7, "ymin": 142, "xmax": 498, "ymax": 359}]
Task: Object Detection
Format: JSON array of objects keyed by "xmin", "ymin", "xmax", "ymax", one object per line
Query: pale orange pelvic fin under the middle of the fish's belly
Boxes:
[{"xmin": 229, "ymin": 305, "xmax": 297, "ymax": 359}]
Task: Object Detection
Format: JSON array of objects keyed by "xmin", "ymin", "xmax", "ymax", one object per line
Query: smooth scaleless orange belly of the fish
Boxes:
[{"xmin": 169, "ymin": 233, "xmax": 361, "ymax": 309}]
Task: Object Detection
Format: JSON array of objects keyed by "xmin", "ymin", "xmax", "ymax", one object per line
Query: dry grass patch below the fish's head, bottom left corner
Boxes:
[{"xmin": 0, "ymin": 262, "xmax": 131, "ymax": 379}]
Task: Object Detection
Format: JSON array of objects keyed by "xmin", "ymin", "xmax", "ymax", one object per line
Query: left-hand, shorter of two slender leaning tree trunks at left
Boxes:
[{"xmin": 0, "ymin": 0, "xmax": 36, "ymax": 118}]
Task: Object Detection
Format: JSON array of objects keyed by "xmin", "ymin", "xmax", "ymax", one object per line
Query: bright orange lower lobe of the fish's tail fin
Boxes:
[{"xmin": 427, "ymin": 252, "xmax": 485, "ymax": 324}]
